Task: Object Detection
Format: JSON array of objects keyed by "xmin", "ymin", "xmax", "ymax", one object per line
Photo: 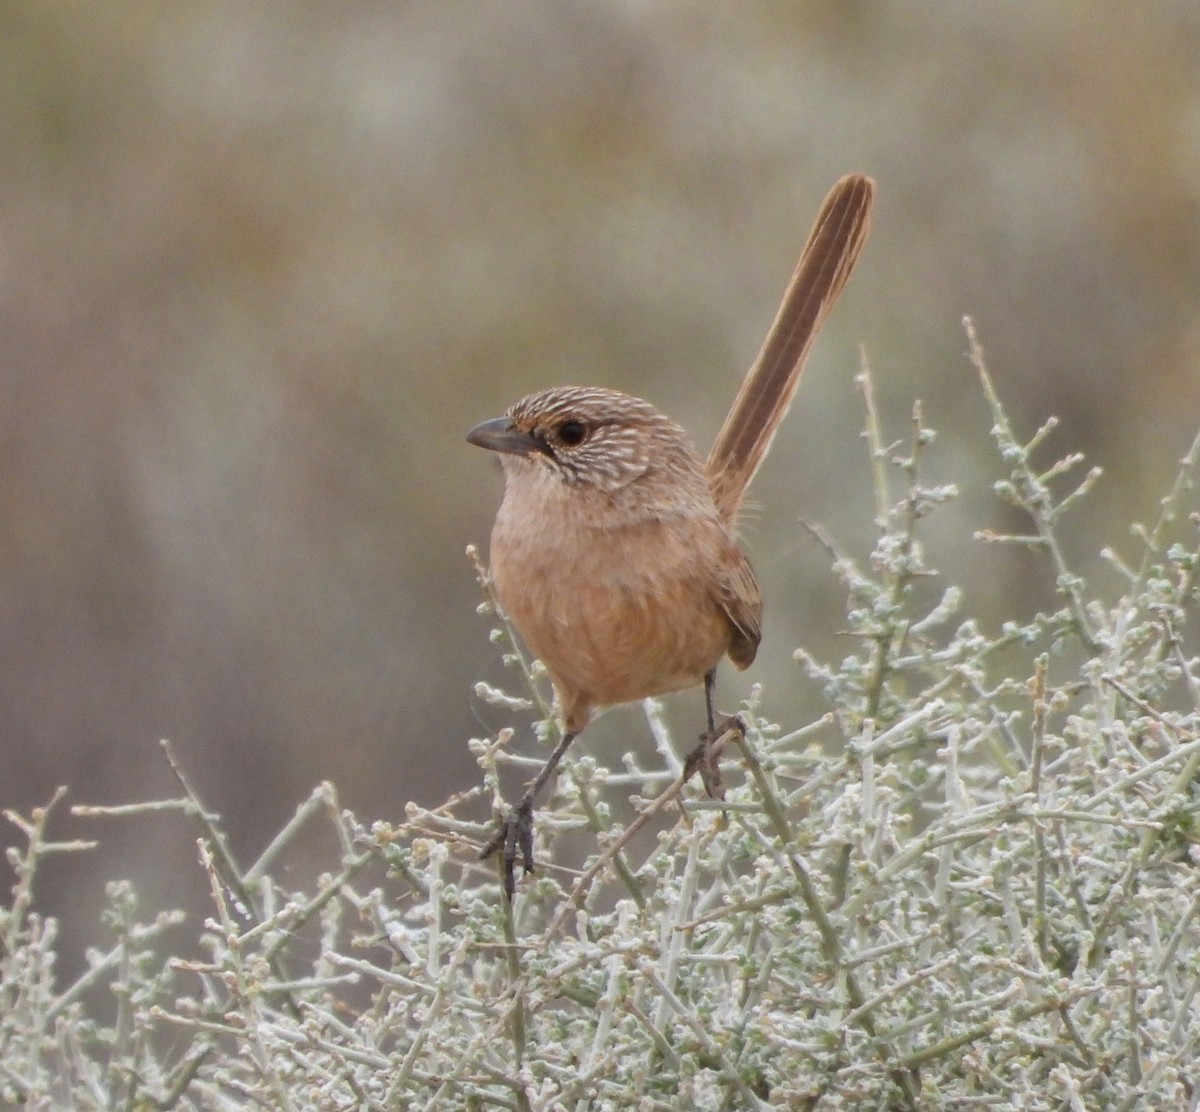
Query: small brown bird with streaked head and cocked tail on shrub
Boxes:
[{"xmin": 467, "ymin": 174, "xmax": 875, "ymax": 896}]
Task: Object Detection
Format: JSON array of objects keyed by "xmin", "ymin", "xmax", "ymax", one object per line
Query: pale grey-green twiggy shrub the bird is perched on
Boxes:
[{"xmin": 0, "ymin": 319, "xmax": 1200, "ymax": 1110}]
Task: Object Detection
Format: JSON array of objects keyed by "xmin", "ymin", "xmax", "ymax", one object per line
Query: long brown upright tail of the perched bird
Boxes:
[{"xmin": 707, "ymin": 174, "xmax": 875, "ymax": 524}]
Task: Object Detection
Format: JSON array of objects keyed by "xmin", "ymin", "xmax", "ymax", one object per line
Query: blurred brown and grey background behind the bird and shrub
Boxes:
[{"xmin": 0, "ymin": 0, "xmax": 1200, "ymax": 951}]
